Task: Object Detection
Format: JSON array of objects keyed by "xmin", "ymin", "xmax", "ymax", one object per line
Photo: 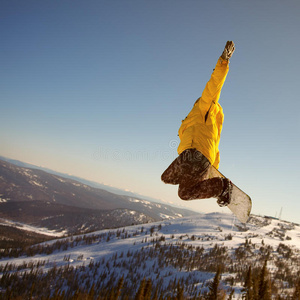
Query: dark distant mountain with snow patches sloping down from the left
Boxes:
[{"xmin": 0, "ymin": 159, "xmax": 197, "ymax": 234}]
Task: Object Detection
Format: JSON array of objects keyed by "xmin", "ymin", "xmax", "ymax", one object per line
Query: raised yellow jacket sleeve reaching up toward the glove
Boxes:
[{"xmin": 197, "ymin": 58, "xmax": 229, "ymax": 116}]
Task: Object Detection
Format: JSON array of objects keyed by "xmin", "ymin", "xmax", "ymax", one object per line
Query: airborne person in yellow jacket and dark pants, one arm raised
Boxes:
[{"xmin": 161, "ymin": 41, "xmax": 235, "ymax": 206}]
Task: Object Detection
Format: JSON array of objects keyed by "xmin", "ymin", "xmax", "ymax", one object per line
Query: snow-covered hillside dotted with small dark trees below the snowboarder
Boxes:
[{"xmin": 0, "ymin": 213, "xmax": 300, "ymax": 299}]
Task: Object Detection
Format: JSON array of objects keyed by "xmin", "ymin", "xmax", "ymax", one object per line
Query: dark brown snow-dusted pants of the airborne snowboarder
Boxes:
[{"xmin": 161, "ymin": 149, "xmax": 223, "ymax": 200}]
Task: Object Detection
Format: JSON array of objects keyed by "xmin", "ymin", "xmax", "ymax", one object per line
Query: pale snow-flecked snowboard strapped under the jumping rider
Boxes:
[{"xmin": 209, "ymin": 166, "xmax": 252, "ymax": 223}]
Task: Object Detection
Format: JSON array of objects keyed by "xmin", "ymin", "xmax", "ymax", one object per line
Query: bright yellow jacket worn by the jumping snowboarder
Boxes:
[{"xmin": 177, "ymin": 58, "xmax": 229, "ymax": 169}]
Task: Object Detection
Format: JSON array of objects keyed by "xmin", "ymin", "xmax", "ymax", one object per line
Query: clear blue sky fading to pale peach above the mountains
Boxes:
[{"xmin": 0, "ymin": 0, "xmax": 300, "ymax": 223}]
